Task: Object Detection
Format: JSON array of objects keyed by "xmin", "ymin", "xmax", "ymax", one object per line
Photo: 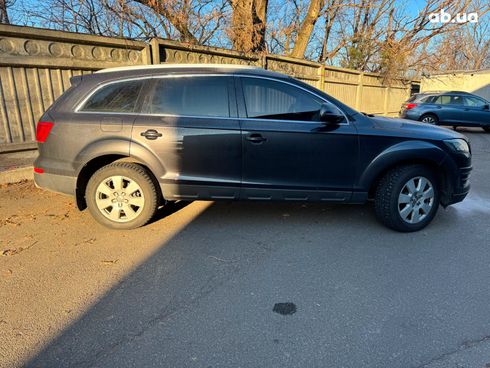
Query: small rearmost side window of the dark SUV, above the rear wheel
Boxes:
[{"xmin": 81, "ymin": 80, "xmax": 144, "ymax": 112}]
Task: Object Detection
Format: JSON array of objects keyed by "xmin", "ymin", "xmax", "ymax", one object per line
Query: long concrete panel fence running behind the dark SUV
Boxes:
[{"xmin": 0, "ymin": 25, "xmax": 413, "ymax": 153}]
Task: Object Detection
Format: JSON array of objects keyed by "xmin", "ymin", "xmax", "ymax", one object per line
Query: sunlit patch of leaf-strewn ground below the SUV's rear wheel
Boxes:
[{"xmin": 0, "ymin": 181, "xmax": 207, "ymax": 367}]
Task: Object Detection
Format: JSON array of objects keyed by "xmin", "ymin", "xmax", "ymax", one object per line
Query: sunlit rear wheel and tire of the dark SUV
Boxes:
[{"xmin": 85, "ymin": 162, "xmax": 158, "ymax": 230}]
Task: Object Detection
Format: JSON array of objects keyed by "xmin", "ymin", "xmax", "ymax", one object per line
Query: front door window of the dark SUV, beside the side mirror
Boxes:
[{"xmin": 242, "ymin": 78, "xmax": 323, "ymax": 121}]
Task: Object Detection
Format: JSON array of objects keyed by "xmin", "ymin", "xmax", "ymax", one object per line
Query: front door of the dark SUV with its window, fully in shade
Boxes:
[{"xmin": 238, "ymin": 77, "xmax": 358, "ymax": 201}]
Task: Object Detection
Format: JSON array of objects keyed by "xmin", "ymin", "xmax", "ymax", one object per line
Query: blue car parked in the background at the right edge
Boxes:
[{"xmin": 400, "ymin": 91, "xmax": 490, "ymax": 132}]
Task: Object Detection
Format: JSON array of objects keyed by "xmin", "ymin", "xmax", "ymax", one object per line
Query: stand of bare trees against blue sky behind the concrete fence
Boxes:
[{"xmin": 7, "ymin": 0, "xmax": 490, "ymax": 78}]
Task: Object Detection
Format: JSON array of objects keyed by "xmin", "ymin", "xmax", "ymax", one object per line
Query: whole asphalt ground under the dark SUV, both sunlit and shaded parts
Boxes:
[{"xmin": 0, "ymin": 128, "xmax": 490, "ymax": 368}]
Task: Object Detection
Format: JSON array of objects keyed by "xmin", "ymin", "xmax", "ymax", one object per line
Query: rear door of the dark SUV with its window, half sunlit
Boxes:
[{"xmin": 131, "ymin": 75, "xmax": 241, "ymax": 199}]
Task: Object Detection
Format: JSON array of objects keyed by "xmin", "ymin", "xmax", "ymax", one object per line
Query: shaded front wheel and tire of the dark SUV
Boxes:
[{"xmin": 374, "ymin": 165, "xmax": 439, "ymax": 232}]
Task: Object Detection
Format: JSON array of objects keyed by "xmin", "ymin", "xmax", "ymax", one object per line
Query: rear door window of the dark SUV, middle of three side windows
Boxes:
[{"xmin": 149, "ymin": 77, "xmax": 230, "ymax": 117}]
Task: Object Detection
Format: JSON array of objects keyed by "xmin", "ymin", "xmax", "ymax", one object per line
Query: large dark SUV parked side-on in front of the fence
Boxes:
[{"xmin": 34, "ymin": 65, "xmax": 471, "ymax": 231}]
